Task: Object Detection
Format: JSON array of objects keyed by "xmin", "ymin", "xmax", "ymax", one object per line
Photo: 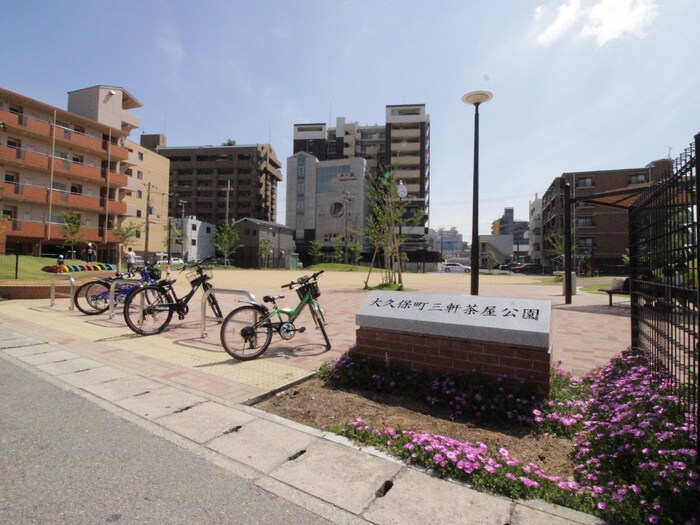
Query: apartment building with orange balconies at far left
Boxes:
[{"xmin": 0, "ymin": 85, "xmax": 141, "ymax": 261}]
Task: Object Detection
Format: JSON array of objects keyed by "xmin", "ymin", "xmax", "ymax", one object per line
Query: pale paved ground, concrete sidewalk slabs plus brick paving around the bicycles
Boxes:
[{"xmin": 0, "ymin": 272, "xmax": 629, "ymax": 525}]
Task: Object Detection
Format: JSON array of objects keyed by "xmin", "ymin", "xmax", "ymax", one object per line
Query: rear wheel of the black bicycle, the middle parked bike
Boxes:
[{"xmin": 124, "ymin": 285, "xmax": 174, "ymax": 335}]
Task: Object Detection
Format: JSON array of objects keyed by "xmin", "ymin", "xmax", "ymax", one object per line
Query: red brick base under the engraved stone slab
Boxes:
[{"xmin": 356, "ymin": 327, "xmax": 551, "ymax": 396}]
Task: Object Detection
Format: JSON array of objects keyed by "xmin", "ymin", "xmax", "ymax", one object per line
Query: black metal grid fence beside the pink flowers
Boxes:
[{"xmin": 629, "ymin": 134, "xmax": 700, "ymax": 434}]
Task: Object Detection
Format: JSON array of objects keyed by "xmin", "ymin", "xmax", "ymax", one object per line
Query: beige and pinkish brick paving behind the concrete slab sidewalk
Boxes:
[{"xmin": 0, "ymin": 271, "xmax": 630, "ymax": 403}]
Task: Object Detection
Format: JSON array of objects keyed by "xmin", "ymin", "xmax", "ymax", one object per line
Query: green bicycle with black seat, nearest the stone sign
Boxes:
[{"xmin": 221, "ymin": 270, "xmax": 331, "ymax": 361}]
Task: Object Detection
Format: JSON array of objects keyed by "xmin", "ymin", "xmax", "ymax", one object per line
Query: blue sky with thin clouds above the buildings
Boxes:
[{"xmin": 0, "ymin": 0, "xmax": 700, "ymax": 233}]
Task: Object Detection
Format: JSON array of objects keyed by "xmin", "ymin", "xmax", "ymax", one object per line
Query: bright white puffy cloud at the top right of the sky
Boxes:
[{"xmin": 535, "ymin": 0, "xmax": 658, "ymax": 47}]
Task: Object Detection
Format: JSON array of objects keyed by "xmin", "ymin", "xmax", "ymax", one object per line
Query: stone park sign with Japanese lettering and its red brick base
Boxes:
[{"xmin": 356, "ymin": 291, "xmax": 551, "ymax": 397}]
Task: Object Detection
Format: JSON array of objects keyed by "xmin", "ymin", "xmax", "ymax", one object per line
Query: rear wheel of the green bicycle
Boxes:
[{"xmin": 221, "ymin": 305, "xmax": 272, "ymax": 361}]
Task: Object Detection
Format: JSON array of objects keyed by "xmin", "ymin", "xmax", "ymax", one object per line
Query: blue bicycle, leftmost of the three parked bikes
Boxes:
[{"xmin": 73, "ymin": 265, "xmax": 161, "ymax": 315}]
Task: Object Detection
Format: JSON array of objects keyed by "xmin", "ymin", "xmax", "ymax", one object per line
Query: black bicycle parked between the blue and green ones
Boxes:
[{"xmin": 124, "ymin": 257, "xmax": 223, "ymax": 335}]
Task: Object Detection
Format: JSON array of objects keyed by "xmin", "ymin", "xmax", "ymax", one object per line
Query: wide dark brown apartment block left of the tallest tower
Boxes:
[{"xmin": 156, "ymin": 144, "xmax": 282, "ymax": 226}]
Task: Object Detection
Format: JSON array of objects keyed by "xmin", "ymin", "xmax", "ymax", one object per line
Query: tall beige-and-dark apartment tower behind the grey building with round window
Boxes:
[{"xmin": 287, "ymin": 104, "xmax": 430, "ymax": 257}]
